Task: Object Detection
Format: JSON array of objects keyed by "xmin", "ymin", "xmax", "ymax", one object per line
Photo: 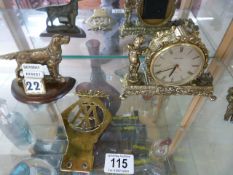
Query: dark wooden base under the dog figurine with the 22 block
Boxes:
[{"xmin": 11, "ymin": 77, "xmax": 76, "ymax": 104}]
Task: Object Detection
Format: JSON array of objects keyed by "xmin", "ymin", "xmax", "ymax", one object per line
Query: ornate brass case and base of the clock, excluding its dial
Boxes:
[{"xmin": 121, "ymin": 20, "xmax": 216, "ymax": 100}]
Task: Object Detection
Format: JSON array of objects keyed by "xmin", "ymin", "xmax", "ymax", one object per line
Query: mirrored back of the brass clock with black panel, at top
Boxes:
[{"xmin": 120, "ymin": 0, "xmax": 178, "ymax": 37}]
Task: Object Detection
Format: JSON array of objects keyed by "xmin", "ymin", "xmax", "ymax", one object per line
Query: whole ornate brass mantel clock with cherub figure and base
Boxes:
[{"xmin": 121, "ymin": 20, "xmax": 216, "ymax": 100}]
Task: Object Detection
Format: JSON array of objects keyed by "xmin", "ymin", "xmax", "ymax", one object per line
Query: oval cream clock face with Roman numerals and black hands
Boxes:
[{"xmin": 150, "ymin": 43, "xmax": 205, "ymax": 85}]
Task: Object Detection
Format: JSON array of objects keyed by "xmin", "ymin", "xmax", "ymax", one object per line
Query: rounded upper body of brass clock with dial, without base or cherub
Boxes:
[{"xmin": 146, "ymin": 20, "xmax": 208, "ymax": 86}]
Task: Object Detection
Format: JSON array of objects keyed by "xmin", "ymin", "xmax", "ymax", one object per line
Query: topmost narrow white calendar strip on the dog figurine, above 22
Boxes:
[{"xmin": 22, "ymin": 63, "xmax": 50, "ymax": 75}]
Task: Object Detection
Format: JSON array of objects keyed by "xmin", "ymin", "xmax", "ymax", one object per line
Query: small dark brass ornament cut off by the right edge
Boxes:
[{"xmin": 224, "ymin": 87, "xmax": 233, "ymax": 122}]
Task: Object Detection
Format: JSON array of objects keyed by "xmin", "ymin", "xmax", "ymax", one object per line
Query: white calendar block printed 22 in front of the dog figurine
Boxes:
[{"xmin": 23, "ymin": 78, "xmax": 46, "ymax": 95}]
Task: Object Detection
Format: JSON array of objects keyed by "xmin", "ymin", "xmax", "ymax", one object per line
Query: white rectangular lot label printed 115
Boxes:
[{"xmin": 104, "ymin": 153, "xmax": 134, "ymax": 174}]
